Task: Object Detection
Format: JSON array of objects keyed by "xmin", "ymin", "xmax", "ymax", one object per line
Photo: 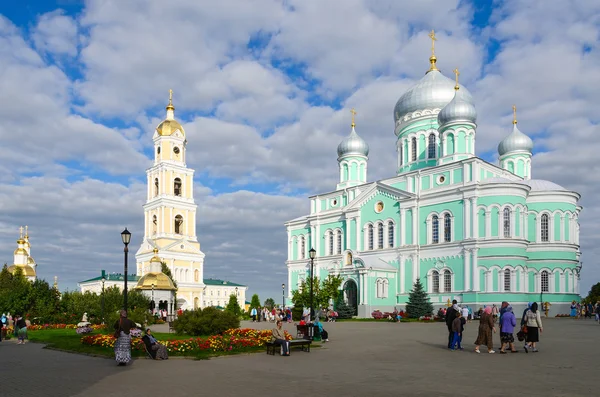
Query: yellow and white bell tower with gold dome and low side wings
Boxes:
[{"xmin": 79, "ymin": 91, "xmax": 247, "ymax": 313}]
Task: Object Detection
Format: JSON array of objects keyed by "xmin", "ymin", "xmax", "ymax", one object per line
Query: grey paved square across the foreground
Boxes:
[{"xmin": 0, "ymin": 319, "xmax": 600, "ymax": 397}]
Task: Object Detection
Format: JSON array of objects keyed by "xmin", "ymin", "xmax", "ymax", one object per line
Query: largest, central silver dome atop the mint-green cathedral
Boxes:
[{"xmin": 394, "ymin": 70, "xmax": 473, "ymax": 121}]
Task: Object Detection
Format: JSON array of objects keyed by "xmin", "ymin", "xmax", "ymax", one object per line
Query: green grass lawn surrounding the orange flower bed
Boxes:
[{"xmin": 27, "ymin": 329, "xmax": 265, "ymax": 360}]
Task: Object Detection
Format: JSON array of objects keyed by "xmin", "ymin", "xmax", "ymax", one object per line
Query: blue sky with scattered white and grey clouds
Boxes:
[{"xmin": 0, "ymin": 0, "xmax": 600, "ymax": 301}]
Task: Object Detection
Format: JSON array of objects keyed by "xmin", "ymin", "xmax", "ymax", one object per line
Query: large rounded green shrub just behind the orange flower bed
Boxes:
[{"xmin": 173, "ymin": 307, "xmax": 240, "ymax": 336}]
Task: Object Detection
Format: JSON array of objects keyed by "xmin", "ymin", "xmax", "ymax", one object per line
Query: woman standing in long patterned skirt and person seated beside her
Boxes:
[{"xmin": 114, "ymin": 310, "xmax": 169, "ymax": 366}]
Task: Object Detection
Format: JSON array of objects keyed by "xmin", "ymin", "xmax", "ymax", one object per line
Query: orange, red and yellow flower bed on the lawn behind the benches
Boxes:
[{"xmin": 81, "ymin": 328, "xmax": 292, "ymax": 354}]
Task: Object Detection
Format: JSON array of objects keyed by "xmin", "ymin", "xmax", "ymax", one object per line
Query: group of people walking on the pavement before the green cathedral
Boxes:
[{"xmin": 445, "ymin": 300, "xmax": 543, "ymax": 354}]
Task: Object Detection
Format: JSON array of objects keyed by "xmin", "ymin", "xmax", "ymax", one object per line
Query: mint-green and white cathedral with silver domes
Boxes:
[{"xmin": 285, "ymin": 48, "xmax": 582, "ymax": 317}]
